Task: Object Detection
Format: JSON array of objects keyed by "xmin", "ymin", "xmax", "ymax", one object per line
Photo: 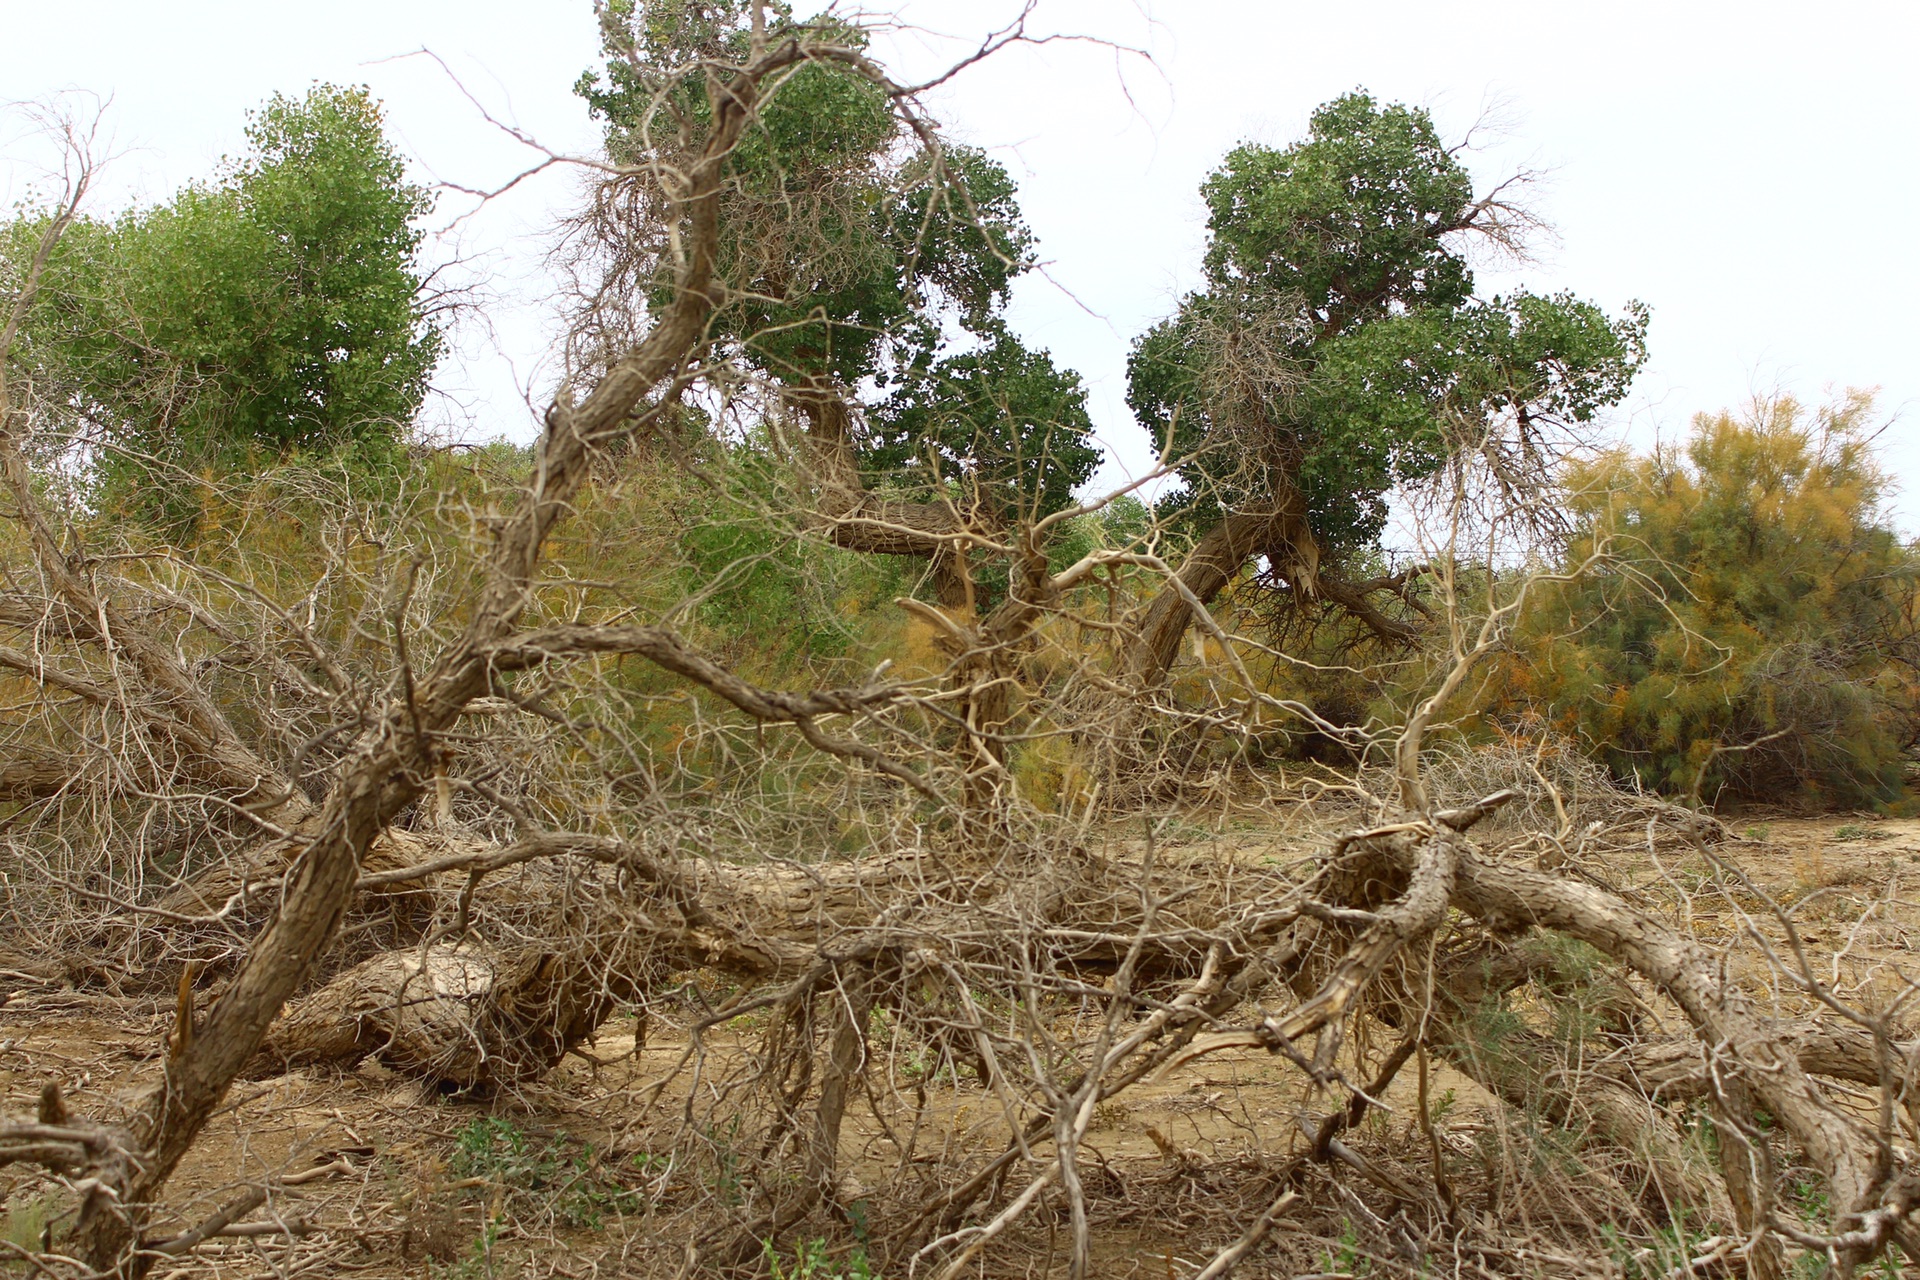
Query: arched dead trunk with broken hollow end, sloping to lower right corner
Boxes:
[{"xmin": 1152, "ymin": 794, "xmax": 1920, "ymax": 1276}]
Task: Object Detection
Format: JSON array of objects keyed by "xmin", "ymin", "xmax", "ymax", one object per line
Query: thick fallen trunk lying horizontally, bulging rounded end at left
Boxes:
[{"xmin": 248, "ymin": 835, "xmax": 1298, "ymax": 1090}]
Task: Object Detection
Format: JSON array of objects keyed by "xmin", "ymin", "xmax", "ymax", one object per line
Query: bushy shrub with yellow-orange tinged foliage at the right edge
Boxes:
[{"xmin": 1492, "ymin": 395, "xmax": 1920, "ymax": 804}]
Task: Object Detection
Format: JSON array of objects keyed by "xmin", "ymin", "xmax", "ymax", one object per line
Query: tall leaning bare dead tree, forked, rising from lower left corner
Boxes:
[{"xmin": 0, "ymin": 29, "xmax": 956, "ymax": 1274}]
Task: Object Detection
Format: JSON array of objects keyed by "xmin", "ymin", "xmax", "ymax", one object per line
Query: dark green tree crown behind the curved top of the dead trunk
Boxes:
[{"xmin": 578, "ymin": 2, "xmax": 1100, "ymax": 520}]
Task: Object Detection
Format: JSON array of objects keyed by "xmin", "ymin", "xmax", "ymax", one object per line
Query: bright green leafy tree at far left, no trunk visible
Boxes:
[{"xmin": 8, "ymin": 84, "xmax": 442, "ymax": 539}]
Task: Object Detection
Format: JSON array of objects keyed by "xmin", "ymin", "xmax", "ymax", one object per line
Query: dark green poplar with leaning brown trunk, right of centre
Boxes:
[{"xmin": 1129, "ymin": 92, "xmax": 1647, "ymax": 683}]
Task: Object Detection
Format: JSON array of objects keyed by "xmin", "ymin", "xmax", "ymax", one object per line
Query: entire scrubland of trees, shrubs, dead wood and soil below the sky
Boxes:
[{"xmin": 0, "ymin": 0, "xmax": 1920, "ymax": 1280}]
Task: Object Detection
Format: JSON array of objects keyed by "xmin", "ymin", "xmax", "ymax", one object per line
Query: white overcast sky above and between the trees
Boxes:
[{"xmin": 11, "ymin": 0, "xmax": 1920, "ymax": 532}]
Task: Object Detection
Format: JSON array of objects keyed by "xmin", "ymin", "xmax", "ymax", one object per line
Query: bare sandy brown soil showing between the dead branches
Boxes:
[{"xmin": 0, "ymin": 816, "xmax": 1920, "ymax": 1280}]
